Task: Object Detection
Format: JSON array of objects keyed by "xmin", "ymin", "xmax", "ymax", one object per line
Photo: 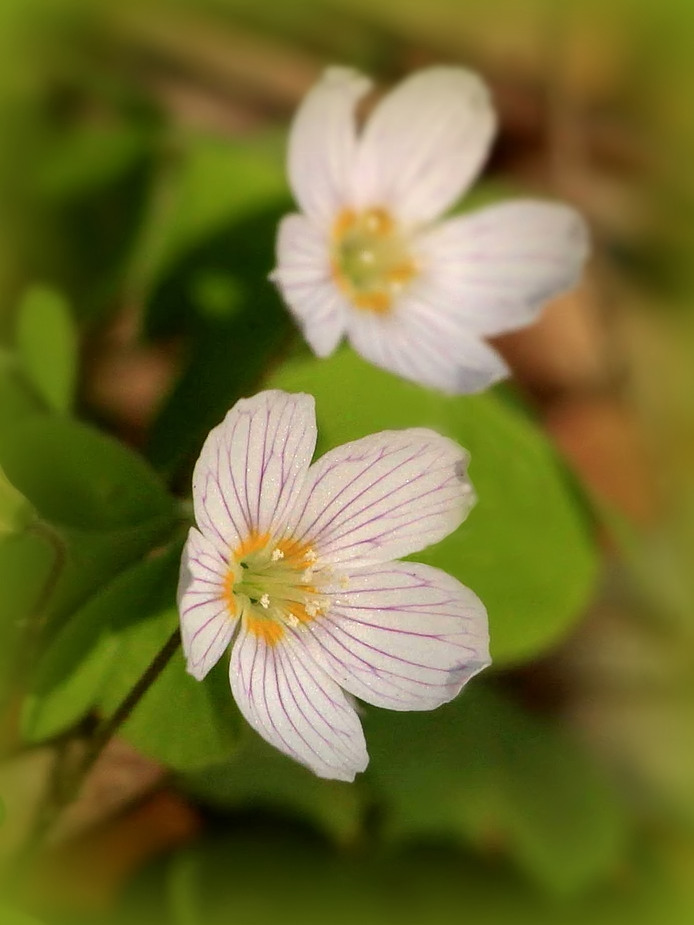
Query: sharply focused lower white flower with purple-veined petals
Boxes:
[{"xmin": 179, "ymin": 391, "xmax": 489, "ymax": 780}]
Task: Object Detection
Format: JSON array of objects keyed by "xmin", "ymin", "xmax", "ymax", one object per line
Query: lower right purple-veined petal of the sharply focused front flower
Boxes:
[{"xmin": 304, "ymin": 562, "xmax": 491, "ymax": 710}]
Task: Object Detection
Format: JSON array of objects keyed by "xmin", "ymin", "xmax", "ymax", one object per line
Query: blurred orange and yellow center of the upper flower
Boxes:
[{"xmin": 332, "ymin": 209, "xmax": 417, "ymax": 314}]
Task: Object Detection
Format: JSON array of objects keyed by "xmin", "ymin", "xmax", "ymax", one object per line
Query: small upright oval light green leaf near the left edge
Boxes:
[{"xmin": 16, "ymin": 286, "xmax": 77, "ymax": 412}]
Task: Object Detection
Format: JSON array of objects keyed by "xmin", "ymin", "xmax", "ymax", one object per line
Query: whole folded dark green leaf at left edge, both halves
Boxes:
[{"xmin": 0, "ymin": 415, "xmax": 178, "ymax": 656}]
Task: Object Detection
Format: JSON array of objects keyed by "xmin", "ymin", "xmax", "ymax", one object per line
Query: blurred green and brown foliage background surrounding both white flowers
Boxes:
[{"xmin": 0, "ymin": 0, "xmax": 694, "ymax": 925}]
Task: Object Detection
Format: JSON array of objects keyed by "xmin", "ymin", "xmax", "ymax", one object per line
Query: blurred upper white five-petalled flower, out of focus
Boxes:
[{"xmin": 272, "ymin": 67, "xmax": 588, "ymax": 393}]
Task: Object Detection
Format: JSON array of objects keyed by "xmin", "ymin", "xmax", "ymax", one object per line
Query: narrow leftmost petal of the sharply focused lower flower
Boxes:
[{"xmin": 178, "ymin": 527, "xmax": 236, "ymax": 681}]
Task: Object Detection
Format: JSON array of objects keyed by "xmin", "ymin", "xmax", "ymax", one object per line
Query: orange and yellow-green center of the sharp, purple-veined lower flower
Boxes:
[{"xmin": 223, "ymin": 533, "xmax": 327, "ymax": 645}]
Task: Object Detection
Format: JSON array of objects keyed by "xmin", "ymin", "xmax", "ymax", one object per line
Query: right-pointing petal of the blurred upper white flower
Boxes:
[{"xmin": 413, "ymin": 200, "xmax": 589, "ymax": 335}]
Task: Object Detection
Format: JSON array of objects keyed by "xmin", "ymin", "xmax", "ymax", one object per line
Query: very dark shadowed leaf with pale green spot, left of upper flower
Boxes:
[{"xmin": 149, "ymin": 207, "xmax": 292, "ymax": 474}]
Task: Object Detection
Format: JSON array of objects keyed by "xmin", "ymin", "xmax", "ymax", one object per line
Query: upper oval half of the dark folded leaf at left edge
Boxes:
[{"xmin": 0, "ymin": 417, "xmax": 175, "ymax": 530}]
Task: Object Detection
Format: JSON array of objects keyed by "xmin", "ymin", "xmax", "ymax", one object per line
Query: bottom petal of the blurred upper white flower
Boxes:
[{"xmin": 348, "ymin": 308, "xmax": 509, "ymax": 395}]
